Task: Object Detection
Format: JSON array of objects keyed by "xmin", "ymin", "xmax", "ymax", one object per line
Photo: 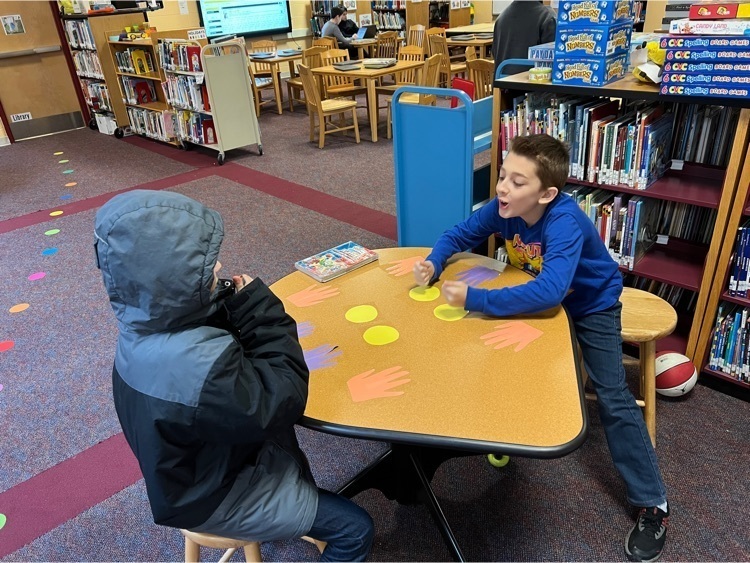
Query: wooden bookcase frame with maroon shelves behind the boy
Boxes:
[{"xmin": 490, "ymin": 73, "xmax": 750, "ymax": 373}]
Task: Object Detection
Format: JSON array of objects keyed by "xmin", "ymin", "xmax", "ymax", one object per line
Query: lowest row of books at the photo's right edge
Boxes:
[{"xmin": 708, "ymin": 304, "xmax": 750, "ymax": 381}]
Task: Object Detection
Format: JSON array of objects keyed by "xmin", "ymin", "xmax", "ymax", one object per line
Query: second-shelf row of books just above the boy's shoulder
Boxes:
[{"xmin": 564, "ymin": 184, "xmax": 716, "ymax": 270}]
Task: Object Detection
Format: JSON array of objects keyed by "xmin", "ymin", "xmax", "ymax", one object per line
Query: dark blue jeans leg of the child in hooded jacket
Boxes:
[{"xmin": 308, "ymin": 489, "xmax": 375, "ymax": 561}]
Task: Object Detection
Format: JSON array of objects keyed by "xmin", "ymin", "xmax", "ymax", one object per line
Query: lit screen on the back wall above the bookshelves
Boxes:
[{"xmin": 198, "ymin": 0, "xmax": 292, "ymax": 39}]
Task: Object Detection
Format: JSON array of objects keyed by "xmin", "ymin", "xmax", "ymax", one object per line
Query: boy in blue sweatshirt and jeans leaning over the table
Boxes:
[{"xmin": 414, "ymin": 135, "xmax": 669, "ymax": 561}]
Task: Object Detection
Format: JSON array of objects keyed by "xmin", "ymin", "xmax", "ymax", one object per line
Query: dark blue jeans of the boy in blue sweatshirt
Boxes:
[{"xmin": 573, "ymin": 301, "xmax": 667, "ymax": 507}]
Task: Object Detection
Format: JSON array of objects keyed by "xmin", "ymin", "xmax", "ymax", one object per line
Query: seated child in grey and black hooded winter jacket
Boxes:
[{"xmin": 95, "ymin": 190, "xmax": 373, "ymax": 561}]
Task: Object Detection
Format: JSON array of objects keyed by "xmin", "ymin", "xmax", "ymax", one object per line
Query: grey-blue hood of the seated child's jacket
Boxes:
[{"xmin": 94, "ymin": 190, "xmax": 224, "ymax": 334}]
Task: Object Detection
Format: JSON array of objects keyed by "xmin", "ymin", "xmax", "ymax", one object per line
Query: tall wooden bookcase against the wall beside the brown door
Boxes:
[{"xmin": 60, "ymin": 10, "xmax": 146, "ymax": 132}]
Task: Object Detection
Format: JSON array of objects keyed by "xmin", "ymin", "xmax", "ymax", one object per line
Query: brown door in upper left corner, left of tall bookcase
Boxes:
[{"xmin": 0, "ymin": 1, "xmax": 83, "ymax": 140}]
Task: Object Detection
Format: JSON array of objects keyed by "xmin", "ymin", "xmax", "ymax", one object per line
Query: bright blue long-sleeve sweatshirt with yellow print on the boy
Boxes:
[{"xmin": 427, "ymin": 193, "xmax": 622, "ymax": 319}]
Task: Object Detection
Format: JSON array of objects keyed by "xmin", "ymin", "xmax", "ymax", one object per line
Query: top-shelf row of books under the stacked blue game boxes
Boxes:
[{"xmin": 499, "ymin": 92, "xmax": 739, "ymax": 189}]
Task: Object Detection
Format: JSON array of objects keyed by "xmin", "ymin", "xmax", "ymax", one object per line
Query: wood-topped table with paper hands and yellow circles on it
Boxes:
[{"xmin": 271, "ymin": 248, "xmax": 586, "ymax": 561}]
